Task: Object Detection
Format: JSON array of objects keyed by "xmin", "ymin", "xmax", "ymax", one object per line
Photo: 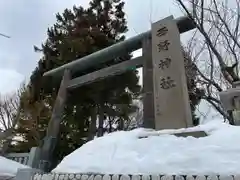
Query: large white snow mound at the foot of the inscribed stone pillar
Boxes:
[{"xmin": 53, "ymin": 122, "xmax": 240, "ymax": 175}]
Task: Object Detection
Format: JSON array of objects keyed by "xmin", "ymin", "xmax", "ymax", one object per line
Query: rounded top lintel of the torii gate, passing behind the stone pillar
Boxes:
[{"xmin": 43, "ymin": 16, "xmax": 195, "ymax": 78}]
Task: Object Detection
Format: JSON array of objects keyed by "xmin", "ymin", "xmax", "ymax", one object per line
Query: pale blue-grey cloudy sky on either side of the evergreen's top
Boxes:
[{"xmin": 0, "ymin": 0, "xmax": 222, "ymax": 122}]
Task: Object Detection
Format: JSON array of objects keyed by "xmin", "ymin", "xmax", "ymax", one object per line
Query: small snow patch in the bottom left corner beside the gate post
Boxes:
[{"xmin": 0, "ymin": 156, "xmax": 30, "ymax": 177}]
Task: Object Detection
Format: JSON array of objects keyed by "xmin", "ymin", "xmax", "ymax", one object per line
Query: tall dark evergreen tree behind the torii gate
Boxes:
[{"xmin": 15, "ymin": 0, "xmax": 140, "ymax": 165}]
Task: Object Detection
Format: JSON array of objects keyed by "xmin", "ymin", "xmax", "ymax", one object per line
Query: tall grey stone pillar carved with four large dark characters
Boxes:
[{"xmin": 152, "ymin": 16, "xmax": 192, "ymax": 130}]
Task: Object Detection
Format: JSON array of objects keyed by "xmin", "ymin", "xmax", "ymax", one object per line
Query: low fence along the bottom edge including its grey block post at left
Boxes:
[{"xmin": 5, "ymin": 169, "xmax": 240, "ymax": 180}]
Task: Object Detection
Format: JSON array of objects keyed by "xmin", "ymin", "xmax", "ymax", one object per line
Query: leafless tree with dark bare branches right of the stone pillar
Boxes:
[{"xmin": 176, "ymin": 0, "xmax": 240, "ymax": 123}]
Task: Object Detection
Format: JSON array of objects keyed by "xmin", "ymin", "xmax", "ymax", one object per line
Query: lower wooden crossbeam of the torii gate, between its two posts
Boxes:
[{"xmin": 68, "ymin": 57, "xmax": 143, "ymax": 89}]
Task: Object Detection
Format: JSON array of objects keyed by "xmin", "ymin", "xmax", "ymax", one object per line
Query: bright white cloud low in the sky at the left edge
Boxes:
[{"xmin": 0, "ymin": 69, "xmax": 24, "ymax": 95}]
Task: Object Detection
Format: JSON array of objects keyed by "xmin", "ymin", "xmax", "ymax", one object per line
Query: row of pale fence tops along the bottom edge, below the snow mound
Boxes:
[{"xmin": 33, "ymin": 174, "xmax": 240, "ymax": 180}]
